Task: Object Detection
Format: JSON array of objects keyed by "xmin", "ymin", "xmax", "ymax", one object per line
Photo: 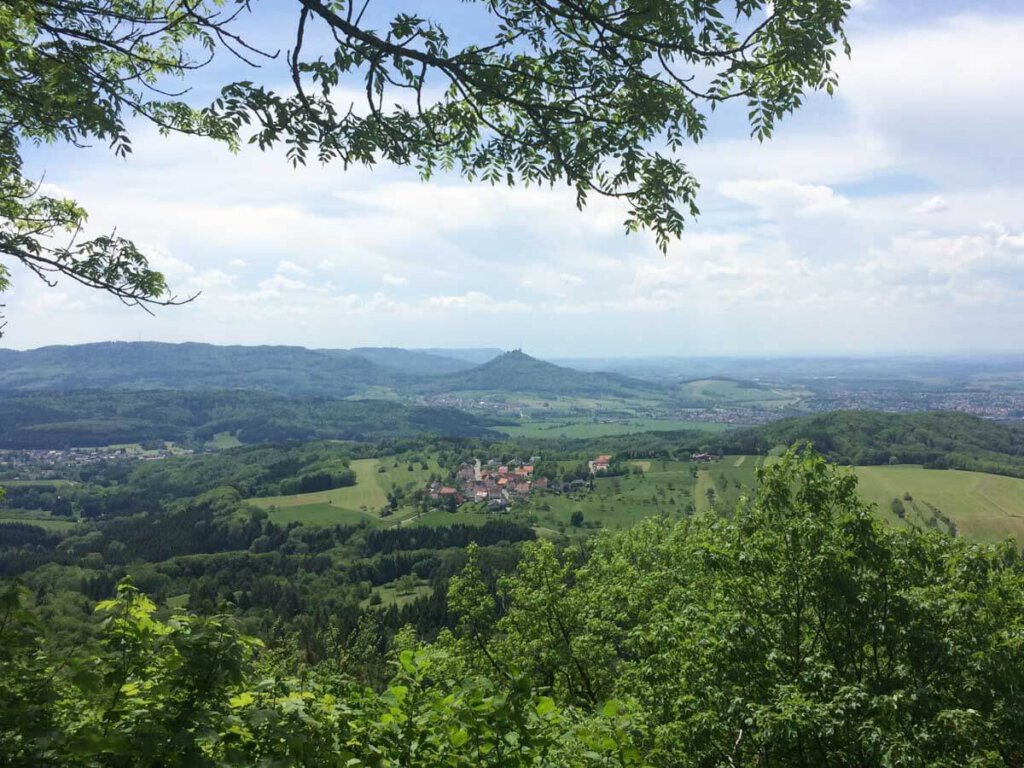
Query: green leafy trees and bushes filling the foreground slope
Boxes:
[{"xmin": 0, "ymin": 453, "xmax": 1024, "ymax": 768}]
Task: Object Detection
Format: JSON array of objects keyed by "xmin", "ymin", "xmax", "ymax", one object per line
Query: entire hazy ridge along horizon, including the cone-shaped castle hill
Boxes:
[{"xmin": 0, "ymin": 342, "xmax": 667, "ymax": 398}]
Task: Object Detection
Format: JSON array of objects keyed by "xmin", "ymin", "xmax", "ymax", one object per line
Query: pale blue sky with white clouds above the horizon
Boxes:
[{"xmin": 2, "ymin": 0, "xmax": 1024, "ymax": 357}]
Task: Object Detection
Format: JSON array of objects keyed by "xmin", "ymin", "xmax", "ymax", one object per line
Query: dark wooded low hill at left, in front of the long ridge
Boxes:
[{"xmin": 0, "ymin": 389, "xmax": 501, "ymax": 449}]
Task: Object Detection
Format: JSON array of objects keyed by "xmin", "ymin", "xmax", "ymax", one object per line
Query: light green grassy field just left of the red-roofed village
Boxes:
[{"xmin": 252, "ymin": 457, "xmax": 440, "ymax": 525}]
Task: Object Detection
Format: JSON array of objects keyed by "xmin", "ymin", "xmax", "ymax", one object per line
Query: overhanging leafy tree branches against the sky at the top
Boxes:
[{"xmin": 0, "ymin": 0, "xmax": 850, "ymax": 335}]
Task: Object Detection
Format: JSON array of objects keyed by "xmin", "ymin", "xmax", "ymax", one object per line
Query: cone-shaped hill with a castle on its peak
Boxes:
[{"xmin": 417, "ymin": 350, "xmax": 665, "ymax": 396}]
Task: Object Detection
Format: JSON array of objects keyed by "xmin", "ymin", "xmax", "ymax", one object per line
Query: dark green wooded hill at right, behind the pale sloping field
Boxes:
[{"xmin": 720, "ymin": 411, "xmax": 1024, "ymax": 477}]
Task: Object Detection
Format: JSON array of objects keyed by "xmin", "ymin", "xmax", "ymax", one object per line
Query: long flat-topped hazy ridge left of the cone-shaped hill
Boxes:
[{"xmin": 0, "ymin": 342, "xmax": 403, "ymax": 396}]
